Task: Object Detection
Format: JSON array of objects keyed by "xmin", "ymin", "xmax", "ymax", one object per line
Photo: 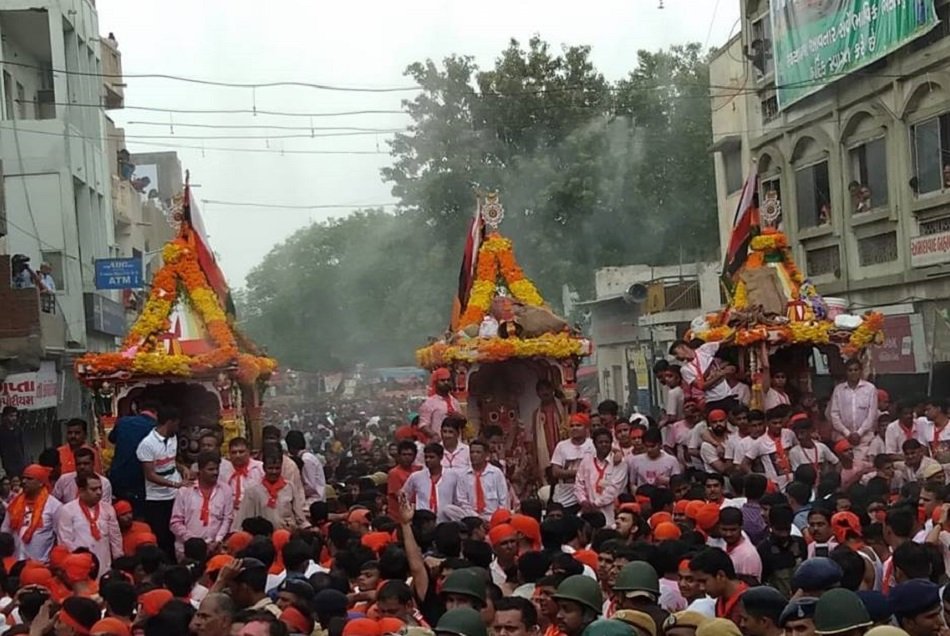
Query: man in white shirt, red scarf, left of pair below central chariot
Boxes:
[{"xmin": 402, "ymin": 442, "xmax": 473, "ymax": 522}]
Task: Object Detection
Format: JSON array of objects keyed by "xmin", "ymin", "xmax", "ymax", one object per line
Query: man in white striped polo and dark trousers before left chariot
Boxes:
[{"xmin": 136, "ymin": 406, "xmax": 184, "ymax": 562}]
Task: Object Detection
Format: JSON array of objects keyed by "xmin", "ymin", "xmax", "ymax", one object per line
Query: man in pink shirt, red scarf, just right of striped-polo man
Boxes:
[{"xmin": 171, "ymin": 451, "xmax": 234, "ymax": 559}]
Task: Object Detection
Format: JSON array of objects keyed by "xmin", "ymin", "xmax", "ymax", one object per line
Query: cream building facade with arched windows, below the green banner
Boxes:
[{"xmin": 710, "ymin": 0, "xmax": 950, "ymax": 391}]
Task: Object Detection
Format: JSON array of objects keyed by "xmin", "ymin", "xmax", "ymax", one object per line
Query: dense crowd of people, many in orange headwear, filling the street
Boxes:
[{"xmin": 0, "ymin": 342, "xmax": 950, "ymax": 636}]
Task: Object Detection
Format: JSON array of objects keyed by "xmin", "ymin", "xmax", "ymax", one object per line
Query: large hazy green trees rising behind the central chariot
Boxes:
[{"xmin": 244, "ymin": 37, "xmax": 718, "ymax": 369}]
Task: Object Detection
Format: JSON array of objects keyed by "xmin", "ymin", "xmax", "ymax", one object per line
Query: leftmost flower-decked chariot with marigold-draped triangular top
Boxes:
[{"xmin": 75, "ymin": 184, "xmax": 276, "ymax": 462}]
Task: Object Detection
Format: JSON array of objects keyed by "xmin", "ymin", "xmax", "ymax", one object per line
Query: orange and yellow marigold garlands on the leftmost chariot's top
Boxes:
[{"xmin": 76, "ymin": 231, "xmax": 277, "ymax": 384}]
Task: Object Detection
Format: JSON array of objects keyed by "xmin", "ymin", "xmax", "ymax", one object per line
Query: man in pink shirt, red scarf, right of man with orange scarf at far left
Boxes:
[{"xmin": 56, "ymin": 475, "xmax": 122, "ymax": 574}]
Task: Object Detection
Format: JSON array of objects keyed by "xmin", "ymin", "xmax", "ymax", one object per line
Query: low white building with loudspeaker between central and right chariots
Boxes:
[{"xmin": 576, "ymin": 263, "xmax": 722, "ymax": 412}]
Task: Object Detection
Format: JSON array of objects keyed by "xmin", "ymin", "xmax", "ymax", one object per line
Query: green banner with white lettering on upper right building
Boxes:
[{"xmin": 770, "ymin": 0, "xmax": 937, "ymax": 108}]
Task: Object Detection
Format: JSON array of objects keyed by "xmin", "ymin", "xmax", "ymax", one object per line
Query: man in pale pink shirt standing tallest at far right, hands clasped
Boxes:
[{"xmin": 828, "ymin": 359, "xmax": 878, "ymax": 459}]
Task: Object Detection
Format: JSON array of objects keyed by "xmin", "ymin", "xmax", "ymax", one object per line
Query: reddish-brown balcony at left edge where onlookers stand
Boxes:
[{"xmin": 0, "ymin": 254, "xmax": 66, "ymax": 371}]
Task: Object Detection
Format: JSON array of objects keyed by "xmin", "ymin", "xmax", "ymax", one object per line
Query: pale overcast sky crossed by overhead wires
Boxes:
[{"xmin": 96, "ymin": 0, "xmax": 740, "ymax": 288}]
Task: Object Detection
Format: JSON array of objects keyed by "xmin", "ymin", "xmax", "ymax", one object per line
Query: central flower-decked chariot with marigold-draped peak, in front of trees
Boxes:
[{"xmin": 416, "ymin": 193, "xmax": 593, "ymax": 496}]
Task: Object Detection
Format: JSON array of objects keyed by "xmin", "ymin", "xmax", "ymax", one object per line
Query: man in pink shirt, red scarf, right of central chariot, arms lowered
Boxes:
[{"xmin": 574, "ymin": 428, "xmax": 627, "ymax": 527}]
